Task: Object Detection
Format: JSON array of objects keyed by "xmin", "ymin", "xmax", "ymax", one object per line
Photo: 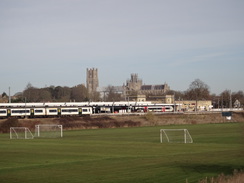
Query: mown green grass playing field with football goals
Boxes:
[{"xmin": 0, "ymin": 123, "xmax": 244, "ymax": 183}]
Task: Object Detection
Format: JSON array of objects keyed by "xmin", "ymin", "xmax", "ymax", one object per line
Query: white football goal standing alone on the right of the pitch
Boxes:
[{"xmin": 160, "ymin": 129, "xmax": 193, "ymax": 143}]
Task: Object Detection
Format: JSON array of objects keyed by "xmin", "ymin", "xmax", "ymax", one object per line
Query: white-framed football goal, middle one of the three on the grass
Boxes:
[{"xmin": 35, "ymin": 124, "xmax": 63, "ymax": 138}]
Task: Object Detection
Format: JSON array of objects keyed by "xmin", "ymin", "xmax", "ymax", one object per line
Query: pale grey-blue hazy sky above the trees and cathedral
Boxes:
[{"xmin": 0, "ymin": 0, "xmax": 244, "ymax": 95}]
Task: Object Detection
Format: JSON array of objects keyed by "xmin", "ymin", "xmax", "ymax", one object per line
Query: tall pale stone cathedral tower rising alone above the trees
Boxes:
[{"xmin": 86, "ymin": 68, "xmax": 98, "ymax": 94}]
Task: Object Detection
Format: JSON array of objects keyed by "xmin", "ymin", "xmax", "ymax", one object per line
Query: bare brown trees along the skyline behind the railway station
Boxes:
[{"xmin": 2, "ymin": 79, "xmax": 244, "ymax": 108}]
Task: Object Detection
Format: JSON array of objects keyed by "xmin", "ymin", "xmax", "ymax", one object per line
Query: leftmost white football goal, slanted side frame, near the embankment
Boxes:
[{"xmin": 10, "ymin": 127, "xmax": 34, "ymax": 139}]
